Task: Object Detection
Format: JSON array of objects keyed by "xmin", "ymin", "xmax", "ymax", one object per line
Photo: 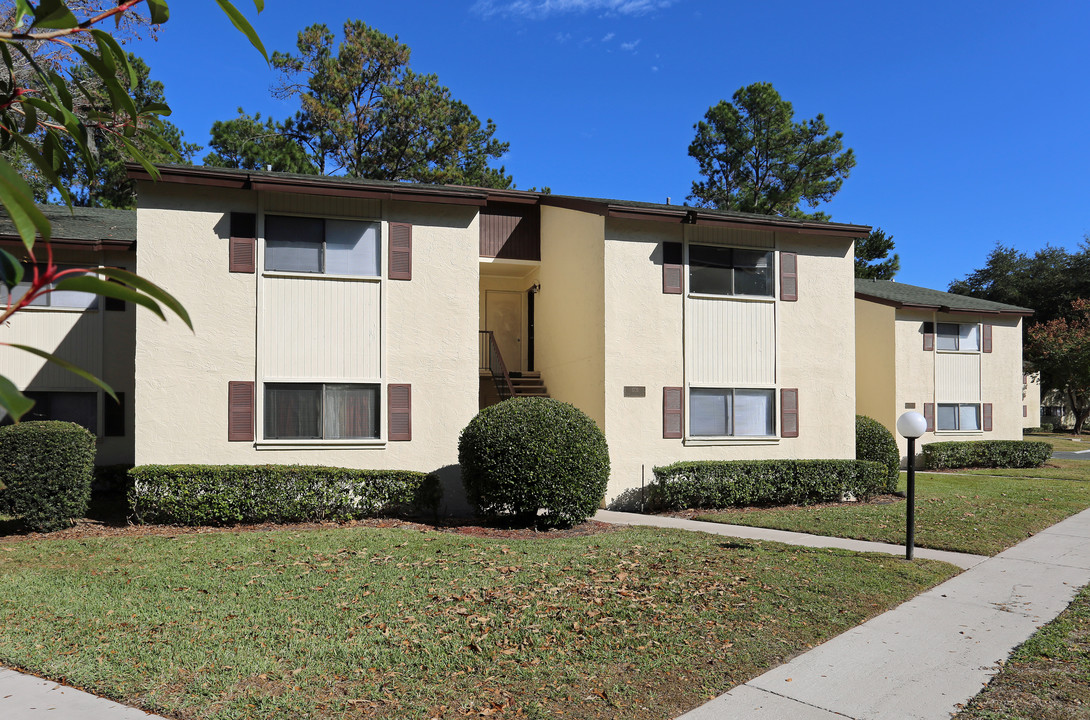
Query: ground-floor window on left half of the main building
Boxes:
[{"xmin": 265, "ymin": 382, "xmax": 378, "ymax": 440}]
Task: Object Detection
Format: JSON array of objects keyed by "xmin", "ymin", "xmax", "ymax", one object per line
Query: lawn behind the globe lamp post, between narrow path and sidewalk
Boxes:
[{"xmin": 695, "ymin": 472, "xmax": 1090, "ymax": 556}]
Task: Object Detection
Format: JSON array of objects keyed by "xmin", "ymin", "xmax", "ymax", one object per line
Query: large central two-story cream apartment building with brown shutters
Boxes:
[{"xmin": 131, "ymin": 167, "xmax": 872, "ymax": 507}]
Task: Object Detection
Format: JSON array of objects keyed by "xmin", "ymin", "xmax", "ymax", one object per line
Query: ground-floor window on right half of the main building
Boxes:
[{"xmin": 689, "ymin": 388, "xmax": 776, "ymax": 438}]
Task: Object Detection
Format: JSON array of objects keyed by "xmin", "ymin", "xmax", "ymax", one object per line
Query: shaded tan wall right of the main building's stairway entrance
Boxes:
[{"xmin": 534, "ymin": 207, "xmax": 608, "ymax": 432}]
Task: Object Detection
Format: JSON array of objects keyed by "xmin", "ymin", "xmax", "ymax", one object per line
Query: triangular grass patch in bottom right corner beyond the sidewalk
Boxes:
[{"xmin": 955, "ymin": 588, "xmax": 1090, "ymax": 720}]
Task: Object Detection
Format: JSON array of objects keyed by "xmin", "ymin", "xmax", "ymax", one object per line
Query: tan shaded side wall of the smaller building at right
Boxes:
[{"xmin": 856, "ymin": 300, "xmax": 897, "ymax": 432}]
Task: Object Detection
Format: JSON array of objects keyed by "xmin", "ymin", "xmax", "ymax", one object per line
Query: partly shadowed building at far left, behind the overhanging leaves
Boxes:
[{"xmin": 0, "ymin": 206, "xmax": 136, "ymax": 465}]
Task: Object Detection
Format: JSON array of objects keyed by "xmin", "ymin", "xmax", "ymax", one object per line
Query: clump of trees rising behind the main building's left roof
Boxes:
[{"xmin": 206, "ymin": 20, "xmax": 511, "ymax": 187}]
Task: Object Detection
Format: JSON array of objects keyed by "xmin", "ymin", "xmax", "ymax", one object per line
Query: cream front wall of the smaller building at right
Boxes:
[{"xmin": 894, "ymin": 308, "xmax": 1022, "ymax": 456}]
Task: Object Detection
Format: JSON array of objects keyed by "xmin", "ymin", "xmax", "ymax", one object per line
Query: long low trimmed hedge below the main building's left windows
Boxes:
[{"xmin": 129, "ymin": 465, "xmax": 443, "ymax": 525}]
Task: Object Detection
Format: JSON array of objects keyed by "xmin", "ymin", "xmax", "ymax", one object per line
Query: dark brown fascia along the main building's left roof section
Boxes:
[{"xmin": 125, "ymin": 163, "xmax": 488, "ymax": 207}]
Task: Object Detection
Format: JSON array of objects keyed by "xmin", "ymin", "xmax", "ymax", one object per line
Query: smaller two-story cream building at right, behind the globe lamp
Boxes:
[{"xmin": 856, "ymin": 280, "xmax": 1033, "ymax": 455}]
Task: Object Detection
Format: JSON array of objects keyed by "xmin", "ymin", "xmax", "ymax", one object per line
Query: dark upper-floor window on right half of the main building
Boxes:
[{"xmin": 689, "ymin": 245, "xmax": 773, "ymax": 297}]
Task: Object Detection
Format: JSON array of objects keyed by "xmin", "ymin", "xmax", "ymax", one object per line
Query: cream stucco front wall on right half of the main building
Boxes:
[{"xmin": 605, "ymin": 219, "xmax": 856, "ymax": 503}]
